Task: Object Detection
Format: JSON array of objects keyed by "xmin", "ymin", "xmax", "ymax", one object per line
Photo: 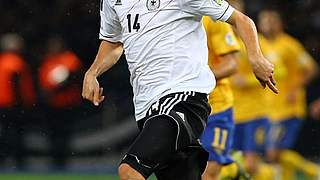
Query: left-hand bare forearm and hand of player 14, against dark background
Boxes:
[{"xmin": 82, "ymin": 41, "xmax": 123, "ymax": 106}]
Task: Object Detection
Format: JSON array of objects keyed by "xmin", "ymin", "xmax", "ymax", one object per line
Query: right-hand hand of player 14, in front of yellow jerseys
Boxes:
[{"xmin": 250, "ymin": 55, "xmax": 279, "ymax": 94}]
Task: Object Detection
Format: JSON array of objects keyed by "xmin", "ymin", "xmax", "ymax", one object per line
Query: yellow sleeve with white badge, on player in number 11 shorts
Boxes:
[{"xmin": 203, "ymin": 17, "xmax": 240, "ymax": 56}]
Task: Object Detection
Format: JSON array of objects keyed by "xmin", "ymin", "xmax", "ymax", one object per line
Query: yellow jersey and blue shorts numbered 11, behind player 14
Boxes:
[{"xmin": 201, "ymin": 17, "xmax": 240, "ymax": 164}]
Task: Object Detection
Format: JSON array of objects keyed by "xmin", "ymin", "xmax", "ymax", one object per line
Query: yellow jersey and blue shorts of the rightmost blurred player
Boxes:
[{"xmin": 269, "ymin": 33, "xmax": 315, "ymax": 149}]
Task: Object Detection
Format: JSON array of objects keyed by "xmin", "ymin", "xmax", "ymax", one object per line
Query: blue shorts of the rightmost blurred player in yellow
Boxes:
[{"xmin": 270, "ymin": 117, "xmax": 303, "ymax": 149}]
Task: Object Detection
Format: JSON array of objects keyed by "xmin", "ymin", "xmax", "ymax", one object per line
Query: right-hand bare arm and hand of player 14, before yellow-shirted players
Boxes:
[{"xmin": 227, "ymin": 10, "xmax": 279, "ymax": 93}]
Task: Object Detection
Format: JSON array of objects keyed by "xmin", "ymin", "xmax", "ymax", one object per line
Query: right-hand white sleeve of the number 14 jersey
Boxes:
[{"xmin": 179, "ymin": 0, "xmax": 234, "ymax": 21}]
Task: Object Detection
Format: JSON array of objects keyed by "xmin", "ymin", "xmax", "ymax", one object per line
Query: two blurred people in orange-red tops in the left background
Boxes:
[{"xmin": 0, "ymin": 34, "xmax": 82, "ymax": 169}]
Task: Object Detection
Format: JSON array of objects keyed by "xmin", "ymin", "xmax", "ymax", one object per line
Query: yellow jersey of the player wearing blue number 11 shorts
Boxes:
[{"xmin": 202, "ymin": 17, "xmax": 240, "ymax": 114}]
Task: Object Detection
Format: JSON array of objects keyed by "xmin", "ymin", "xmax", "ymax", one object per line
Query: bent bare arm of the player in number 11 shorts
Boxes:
[{"xmin": 210, "ymin": 52, "xmax": 238, "ymax": 80}]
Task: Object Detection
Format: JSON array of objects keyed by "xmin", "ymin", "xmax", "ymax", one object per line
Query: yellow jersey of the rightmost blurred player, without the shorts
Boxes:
[{"xmin": 269, "ymin": 33, "xmax": 316, "ymax": 121}]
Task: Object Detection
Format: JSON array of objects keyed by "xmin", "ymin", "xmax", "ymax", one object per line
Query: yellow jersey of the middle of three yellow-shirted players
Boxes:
[{"xmin": 232, "ymin": 35, "xmax": 286, "ymax": 123}]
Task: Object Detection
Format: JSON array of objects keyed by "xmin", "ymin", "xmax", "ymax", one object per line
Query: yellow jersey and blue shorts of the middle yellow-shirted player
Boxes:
[{"xmin": 232, "ymin": 35, "xmax": 286, "ymax": 152}]
